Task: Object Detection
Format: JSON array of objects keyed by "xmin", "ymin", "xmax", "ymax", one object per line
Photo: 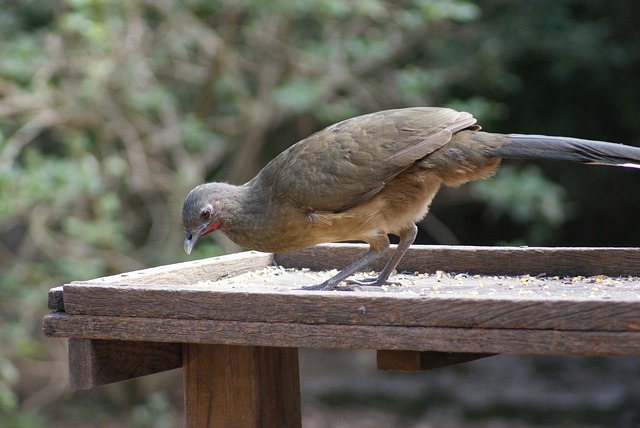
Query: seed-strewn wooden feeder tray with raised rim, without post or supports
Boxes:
[{"xmin": 44, "ymin": 244, "xmax": 640, "ymax": 355}]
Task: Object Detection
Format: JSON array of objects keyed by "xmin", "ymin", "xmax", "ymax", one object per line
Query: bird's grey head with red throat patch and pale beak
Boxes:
[{"xmin": 182, "ymin": 184, "xmax": 220, "ymax": 254}]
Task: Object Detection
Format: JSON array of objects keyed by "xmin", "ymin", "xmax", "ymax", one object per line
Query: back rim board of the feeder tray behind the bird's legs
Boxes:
[{"xmin": 275, "ymin": 244, "xmax": 640, "ymax": 276}]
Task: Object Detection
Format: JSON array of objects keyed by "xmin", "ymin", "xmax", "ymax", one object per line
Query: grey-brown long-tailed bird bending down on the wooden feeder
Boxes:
[{"xmin": 182, "ymin": 107, "xmax": 640, "ymax": 290}]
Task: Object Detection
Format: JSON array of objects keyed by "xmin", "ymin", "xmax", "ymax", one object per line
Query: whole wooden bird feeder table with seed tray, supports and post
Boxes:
[{"xmin": 44, "ymin": 244, "xmax": 640, "ymax": 428}]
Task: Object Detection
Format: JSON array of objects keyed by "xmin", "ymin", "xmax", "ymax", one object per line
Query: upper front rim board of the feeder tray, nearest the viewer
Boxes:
[{"xmin": 64, "ymin": 283, "xmax": 640, "ymax": 331}]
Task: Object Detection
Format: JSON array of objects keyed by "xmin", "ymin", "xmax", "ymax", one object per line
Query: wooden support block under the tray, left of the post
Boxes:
[{"xmin": 69, "ymin": 338, "xmax": 182, "ymax": 389}]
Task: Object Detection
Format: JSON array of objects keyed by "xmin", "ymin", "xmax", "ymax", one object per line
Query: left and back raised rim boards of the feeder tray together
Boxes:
[{"xmin": 53, "ymin": 244, "xmax": 640, "ymax": 292}]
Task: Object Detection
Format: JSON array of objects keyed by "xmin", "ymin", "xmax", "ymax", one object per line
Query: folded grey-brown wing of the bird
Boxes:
[{"xmin": 256, "ymin": 107, "xmax": 476, "ymax": 212}]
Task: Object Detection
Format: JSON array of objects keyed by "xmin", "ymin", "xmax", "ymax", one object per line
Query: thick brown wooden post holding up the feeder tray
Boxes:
[{"xmin": 182, "ymin": 343, "xmax": 302, "ymax": 428}]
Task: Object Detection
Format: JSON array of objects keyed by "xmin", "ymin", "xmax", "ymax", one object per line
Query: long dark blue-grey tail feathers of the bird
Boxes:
[{"xmin": 489, "ymin": 134, "xmax": 640, "ymax": 168}]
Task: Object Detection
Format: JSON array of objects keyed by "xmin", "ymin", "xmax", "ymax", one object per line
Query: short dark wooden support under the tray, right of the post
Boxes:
[{"xmin": 377, "ymin": 349, "xmax": 496, "ymax": 372}]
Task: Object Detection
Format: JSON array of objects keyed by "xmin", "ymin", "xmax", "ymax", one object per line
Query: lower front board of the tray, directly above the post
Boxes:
[{"xmin": 44, "ymin": 312, "xmax": 640, "ymax": 356}]
